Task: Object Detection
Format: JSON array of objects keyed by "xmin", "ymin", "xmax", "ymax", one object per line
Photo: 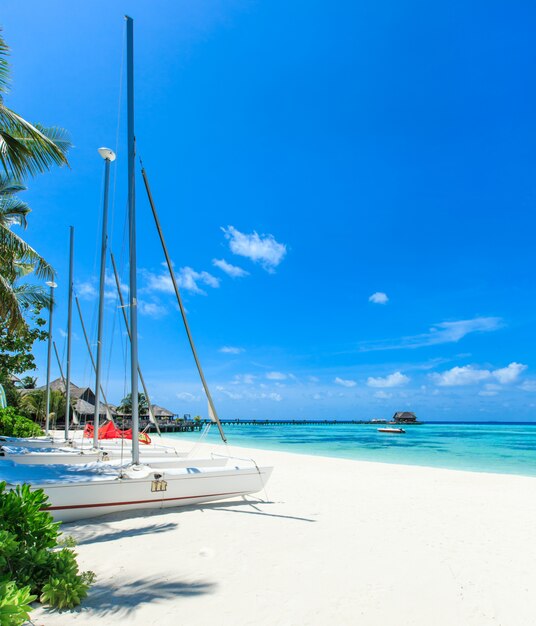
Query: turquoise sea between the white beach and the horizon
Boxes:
[{"xmin": 166, "ymin": 422, "xmax": 536, "ymax": 476}]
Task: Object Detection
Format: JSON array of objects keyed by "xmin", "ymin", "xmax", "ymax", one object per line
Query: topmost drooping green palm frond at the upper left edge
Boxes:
[{"xmin": 0, "ymin": 32, "xmax": 70, "ymax": 179}]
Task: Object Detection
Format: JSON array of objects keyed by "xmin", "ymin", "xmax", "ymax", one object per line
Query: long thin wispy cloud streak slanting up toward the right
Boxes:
[{"xmin": 361, "ymin": 317, "xmax": 503, "ymax": 352}]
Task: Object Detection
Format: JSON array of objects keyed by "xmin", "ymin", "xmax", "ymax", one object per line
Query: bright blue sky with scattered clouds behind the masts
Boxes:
[{"xmin": 1, "ymin": 0, "xmax": 536, "ymax": 420}]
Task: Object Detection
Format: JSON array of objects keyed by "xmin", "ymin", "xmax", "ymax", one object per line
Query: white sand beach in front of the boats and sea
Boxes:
[{"xmin": 32, "ymin": 440, "xmax": 536, "ymax": 626}]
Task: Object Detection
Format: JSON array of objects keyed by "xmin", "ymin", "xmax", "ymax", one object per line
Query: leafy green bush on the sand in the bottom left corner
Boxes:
[{"xmin": 0, "ymin": 483, "xmax": 95, "ymax": 626}]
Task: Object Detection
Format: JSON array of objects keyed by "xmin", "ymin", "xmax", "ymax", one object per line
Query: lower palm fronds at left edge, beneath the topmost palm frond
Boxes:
[{"xmin": 0, "ymin": 175, "xmax": 54, "ymax": 329}]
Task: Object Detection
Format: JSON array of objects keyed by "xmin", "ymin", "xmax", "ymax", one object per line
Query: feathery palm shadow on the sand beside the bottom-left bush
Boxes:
[{"xmin": 39, "ymin": 575, "xmax": 216, "ymax": 623}]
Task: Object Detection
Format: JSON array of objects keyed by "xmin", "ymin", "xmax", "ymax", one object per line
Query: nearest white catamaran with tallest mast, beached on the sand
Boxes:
[{"xmin": 0, "ymin": 17, "xmax": 273, "ymax": 521}]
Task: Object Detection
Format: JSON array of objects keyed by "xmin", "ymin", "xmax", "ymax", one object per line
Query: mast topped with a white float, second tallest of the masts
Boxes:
[{"xmin": 93, "ymin": 148, "xmax": 115, "ymax": 448}]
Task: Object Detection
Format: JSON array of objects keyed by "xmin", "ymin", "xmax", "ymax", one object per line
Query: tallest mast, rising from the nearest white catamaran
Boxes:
[{"xmin": 125, "ymin": 15, "xmax": 140, "ymax": 465}]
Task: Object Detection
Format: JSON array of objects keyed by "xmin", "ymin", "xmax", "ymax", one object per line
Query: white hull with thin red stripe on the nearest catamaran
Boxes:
[{"xmin": 9, "ymin": 465, "xmax": 273, "ymax": 522}]
